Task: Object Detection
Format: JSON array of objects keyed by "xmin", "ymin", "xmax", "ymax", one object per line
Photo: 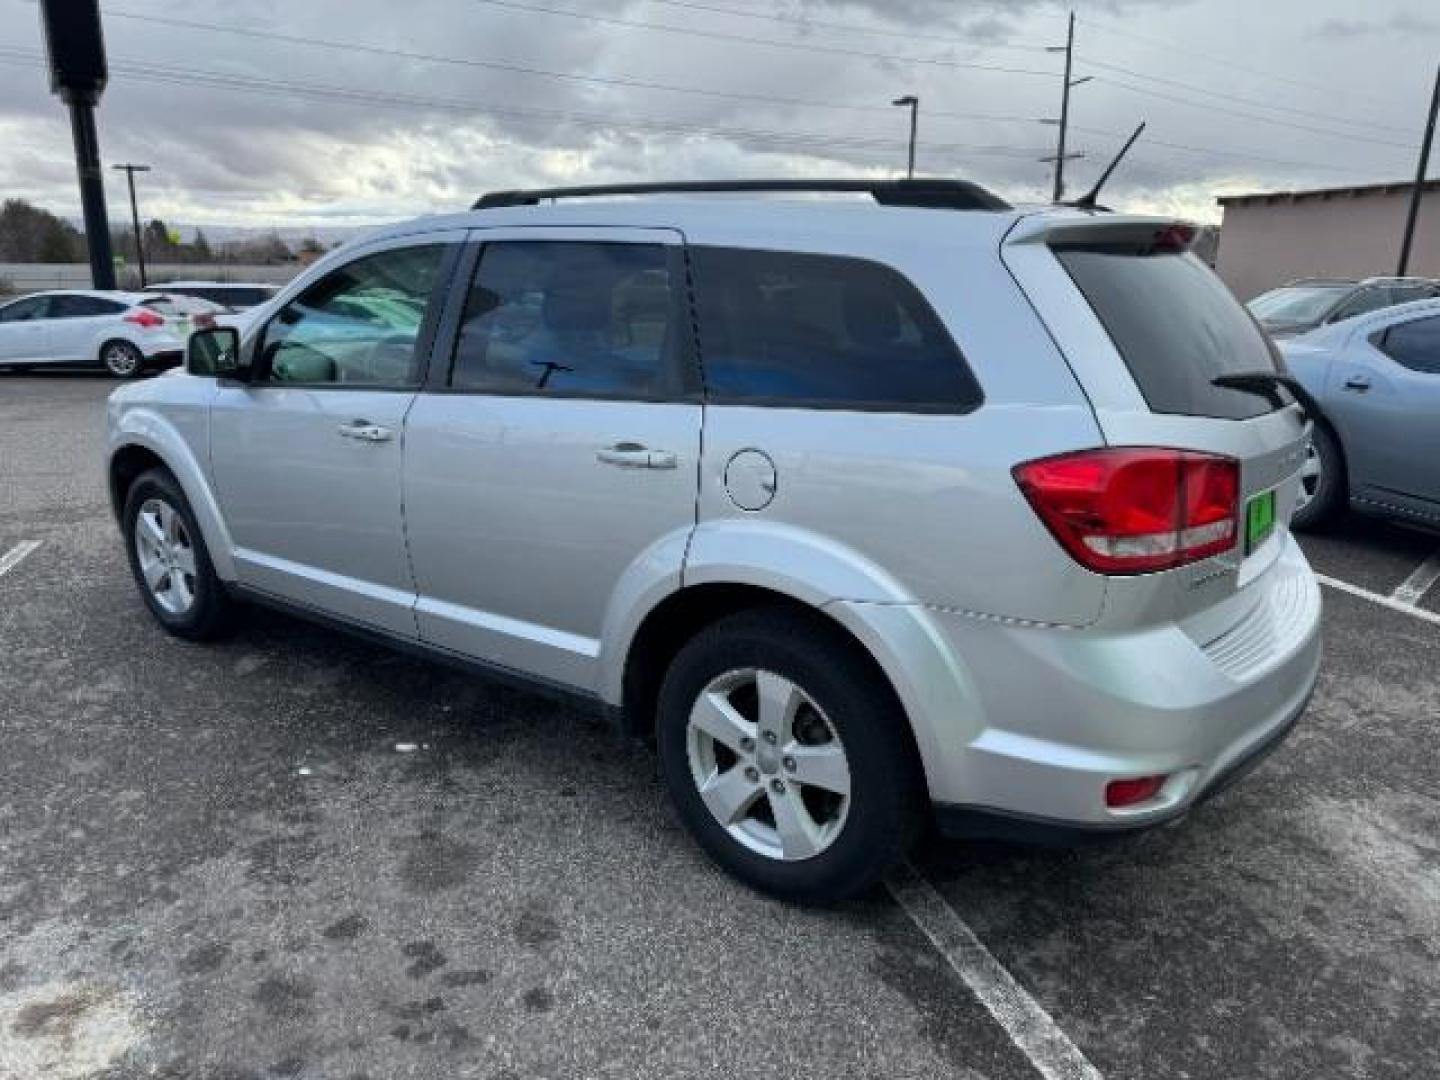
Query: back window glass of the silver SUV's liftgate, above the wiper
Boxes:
[{"xmin": 1054, "ymin": 246, "xmax": 1277, "ymax": 420}]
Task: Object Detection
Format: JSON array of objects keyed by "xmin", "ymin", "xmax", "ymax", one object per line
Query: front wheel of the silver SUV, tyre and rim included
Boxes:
[{"xmin": 121, "ymin": 469, "xmax": 235, "ymax": 641}]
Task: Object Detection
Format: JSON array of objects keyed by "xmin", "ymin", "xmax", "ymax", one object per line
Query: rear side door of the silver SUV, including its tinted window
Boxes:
[{"xmin": 405, "ymin": 229, "xmax": 701, "ymax": 690}]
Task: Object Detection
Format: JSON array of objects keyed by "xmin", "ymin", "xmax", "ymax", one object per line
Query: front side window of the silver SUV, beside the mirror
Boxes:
[{"xmin": 259, "ymin": 243, "xmax": 445, "ymax": 387}]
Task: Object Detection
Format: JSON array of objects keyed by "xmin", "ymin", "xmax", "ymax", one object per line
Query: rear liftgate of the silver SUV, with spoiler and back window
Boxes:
[{"xmin": 1002, "ymin": 213, "xmax": 1308, "ymax": 621}]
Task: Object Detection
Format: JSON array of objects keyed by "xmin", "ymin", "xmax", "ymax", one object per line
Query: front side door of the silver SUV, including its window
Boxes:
[{"xmin": 210, "ymin": 233, "xmax": 464, "ymax": 638}]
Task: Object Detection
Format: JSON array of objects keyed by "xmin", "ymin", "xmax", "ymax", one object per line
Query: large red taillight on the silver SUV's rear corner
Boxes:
[{"xmin": 1014, "ymin": 446, "xmax": 1240, "ymax": 573}]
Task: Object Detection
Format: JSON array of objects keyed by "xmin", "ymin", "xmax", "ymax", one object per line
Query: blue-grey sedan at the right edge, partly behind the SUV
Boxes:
[{"xmin": 1280, "ymin": 300, "xmax": 1440, "ymax": 528}]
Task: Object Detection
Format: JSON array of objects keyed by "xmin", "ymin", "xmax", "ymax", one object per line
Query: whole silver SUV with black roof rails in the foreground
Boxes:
[{"xmin": 108, "ymin": 181, "xmax": 1320, "ymax": 901}]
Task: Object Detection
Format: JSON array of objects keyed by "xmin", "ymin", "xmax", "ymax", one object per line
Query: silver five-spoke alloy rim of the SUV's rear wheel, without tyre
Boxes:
[{"xmin": 685, "ymin": 668, "xmax": 850, "ymax": 863}]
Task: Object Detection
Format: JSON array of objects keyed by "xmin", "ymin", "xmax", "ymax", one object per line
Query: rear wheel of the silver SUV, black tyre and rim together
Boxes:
[{"xmin": 658, "ymin": 609, "xmax": 924, "ymax": 903}]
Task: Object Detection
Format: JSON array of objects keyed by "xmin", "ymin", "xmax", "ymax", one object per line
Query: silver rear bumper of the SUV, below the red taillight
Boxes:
[{"xmin": 848, "ymin": 534, "xmax": 1320, "ymax": 837}]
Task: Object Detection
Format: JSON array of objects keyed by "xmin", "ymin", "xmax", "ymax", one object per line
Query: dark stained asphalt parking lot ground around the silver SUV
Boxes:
[{"xmin": 0, "ymin": 374, "xmax": 1440, "ymax": 1080}]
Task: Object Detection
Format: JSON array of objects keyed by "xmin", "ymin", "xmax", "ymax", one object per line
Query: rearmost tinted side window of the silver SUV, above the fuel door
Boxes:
[{"xmin": 690, "ymin": 246, "xmax": 981, "ymax": 412}]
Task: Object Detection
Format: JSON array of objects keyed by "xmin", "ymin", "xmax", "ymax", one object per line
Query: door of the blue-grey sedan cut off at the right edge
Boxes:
[{"xmin": 1326, "ymin": 310, "xmax": 1440, "ymax": 516}]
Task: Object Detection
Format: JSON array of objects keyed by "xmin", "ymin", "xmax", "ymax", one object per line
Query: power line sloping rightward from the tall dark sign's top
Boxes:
[{"xmin": 105, "ymin": 7, "xmax": 1032, "ymax": 122}]
